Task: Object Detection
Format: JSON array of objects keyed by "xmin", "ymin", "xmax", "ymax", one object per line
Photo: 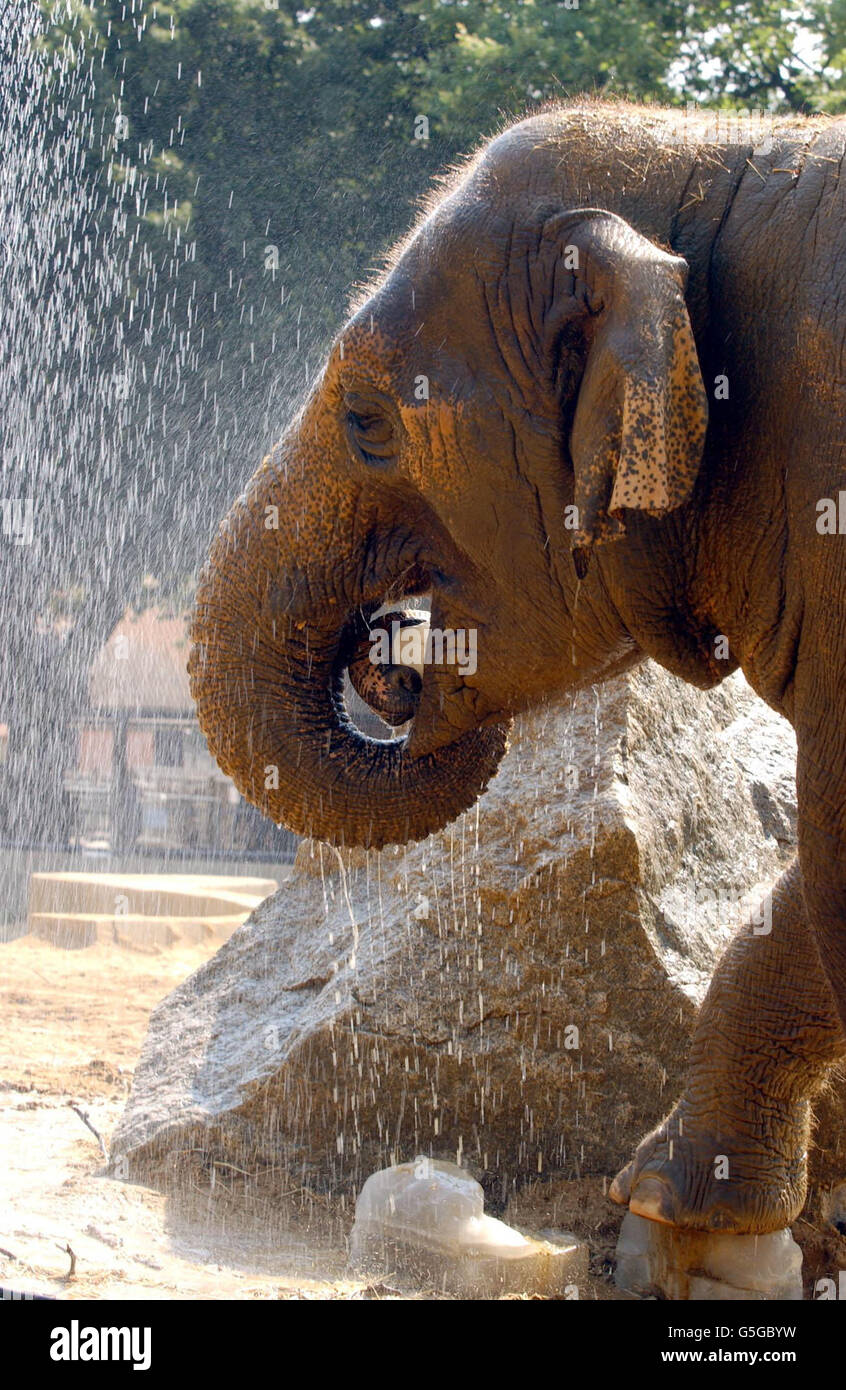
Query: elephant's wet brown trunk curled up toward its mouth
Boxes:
[{"xmin": 189, "ymin": 457, "xmax": 507, "ymax": 849}]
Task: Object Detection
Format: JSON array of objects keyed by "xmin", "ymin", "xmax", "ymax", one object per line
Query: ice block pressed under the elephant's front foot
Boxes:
[{"xmin": 614, "ymin": 1212, "xmax": 802, "ymax": 1301}]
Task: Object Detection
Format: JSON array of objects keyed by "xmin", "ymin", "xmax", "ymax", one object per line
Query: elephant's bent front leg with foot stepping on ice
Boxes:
[{"xmin": 611, "ymin": 862, "xmax": 846, "ymax": 1232}]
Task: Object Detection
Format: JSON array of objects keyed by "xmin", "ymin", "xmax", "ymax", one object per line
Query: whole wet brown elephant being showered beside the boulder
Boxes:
[{"xmin": 189, "ymin": 99, "xmax": 846, "ymax": 1233}]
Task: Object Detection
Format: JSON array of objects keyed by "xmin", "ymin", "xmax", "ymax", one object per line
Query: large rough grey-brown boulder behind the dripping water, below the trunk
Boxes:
[{"xmin": 113, "ymin": 666, "xmax": 839, "ymax": 1195}]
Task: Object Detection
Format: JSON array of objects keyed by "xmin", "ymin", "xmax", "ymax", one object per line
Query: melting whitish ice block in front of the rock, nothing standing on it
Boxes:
[{"xmin": 350, "ymin": 1158, "xmax": 588, "ymax": 1298}]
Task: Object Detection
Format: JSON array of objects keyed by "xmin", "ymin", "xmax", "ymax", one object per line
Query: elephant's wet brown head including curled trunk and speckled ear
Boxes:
[{"xmin": 189, "ymin": 165, "xmax": 707, "ymax": 847}]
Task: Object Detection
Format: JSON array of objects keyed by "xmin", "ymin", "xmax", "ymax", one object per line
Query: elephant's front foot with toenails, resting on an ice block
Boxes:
[{"xmin": 610, "ymin": 1099, "xmax": 810, "ymax": 1234}]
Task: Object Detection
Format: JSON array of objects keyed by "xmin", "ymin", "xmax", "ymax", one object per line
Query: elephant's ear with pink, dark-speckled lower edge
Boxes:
[{"xmin": 543, "ymin": 209, "xmax": 708, "ymax": 578}]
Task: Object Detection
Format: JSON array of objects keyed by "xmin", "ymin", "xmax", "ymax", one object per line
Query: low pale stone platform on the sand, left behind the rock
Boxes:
[{"xmin": 28, "ymin": 873, "xmax": 278, "ymax": 949}]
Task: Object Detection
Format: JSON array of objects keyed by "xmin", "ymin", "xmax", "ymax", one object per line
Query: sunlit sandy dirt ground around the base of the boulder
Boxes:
[{"xmin": 0, "ymin": 937, "xmax": 846, "ymax": 1300}]
